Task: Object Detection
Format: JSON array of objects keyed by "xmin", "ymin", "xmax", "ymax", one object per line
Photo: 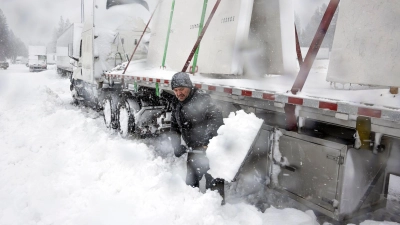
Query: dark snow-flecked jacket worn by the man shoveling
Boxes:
[{"xmin": 171, "ymin": 88, "xmax": 223, "ymax": 157}]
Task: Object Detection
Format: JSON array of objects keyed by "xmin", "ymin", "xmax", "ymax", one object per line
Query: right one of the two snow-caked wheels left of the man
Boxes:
[{"xmin": 118, "ymin": 99, "xmax": 140, "ymax": 137}]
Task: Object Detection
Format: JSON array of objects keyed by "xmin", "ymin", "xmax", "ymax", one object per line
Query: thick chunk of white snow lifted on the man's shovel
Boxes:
[{"xmin": 207, "ymin": 110, "xmax": 263, "ymax": 181}]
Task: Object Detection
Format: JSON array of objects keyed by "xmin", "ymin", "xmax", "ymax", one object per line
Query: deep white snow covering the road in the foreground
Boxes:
[{"xmin": 0, "ymin": 65, "xmax": 398, "ymax": 225}]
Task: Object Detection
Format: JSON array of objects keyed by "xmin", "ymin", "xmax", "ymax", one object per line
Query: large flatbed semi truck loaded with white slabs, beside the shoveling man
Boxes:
[{"xmin": 70, "ymin": 0, "xmax": 400, "ymax": 221}]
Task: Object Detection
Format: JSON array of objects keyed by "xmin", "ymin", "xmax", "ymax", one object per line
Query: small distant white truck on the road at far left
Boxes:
[{"xmin": 28, "ymin": 46, "xmax": 47, "ymax": 72}]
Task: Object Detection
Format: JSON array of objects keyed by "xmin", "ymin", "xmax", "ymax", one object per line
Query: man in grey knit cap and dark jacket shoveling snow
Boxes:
[{"xmin": 171, "ymin": 72, "xmax": 224, "ymax": 204}]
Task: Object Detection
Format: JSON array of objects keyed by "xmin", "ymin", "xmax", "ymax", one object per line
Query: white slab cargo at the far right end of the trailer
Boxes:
[{"xmin": 327, "ymin": 0, "xmax": 400, "ymax": 87}]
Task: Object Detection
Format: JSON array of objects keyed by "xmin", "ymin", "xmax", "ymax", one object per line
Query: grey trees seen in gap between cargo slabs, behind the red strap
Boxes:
[{"xmin": 300, "ymin": 4, "xmax": 339, "ymax": 49}]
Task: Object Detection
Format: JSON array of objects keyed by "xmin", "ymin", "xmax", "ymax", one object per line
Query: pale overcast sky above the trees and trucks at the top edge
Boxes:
[{"xmin": 0, "ymin": 0, "xmax": 329, "ymax": 44}]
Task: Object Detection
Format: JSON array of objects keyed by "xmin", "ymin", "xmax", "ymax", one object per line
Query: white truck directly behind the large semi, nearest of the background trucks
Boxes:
[{"xmin": 56, "ymin": 23, "xmax": 82, "ymax": 77}]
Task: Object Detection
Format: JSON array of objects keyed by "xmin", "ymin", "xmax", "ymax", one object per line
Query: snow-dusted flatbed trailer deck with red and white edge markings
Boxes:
[{"xmin": 105, "ymin": 60, "xmax": 400, "ymax": 122}]
